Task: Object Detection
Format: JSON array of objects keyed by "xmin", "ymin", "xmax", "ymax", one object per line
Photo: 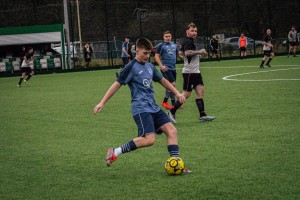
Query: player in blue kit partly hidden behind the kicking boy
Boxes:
[{"xmin": 155, "ymin": 31, "xmax": 182, "ymax": 110}]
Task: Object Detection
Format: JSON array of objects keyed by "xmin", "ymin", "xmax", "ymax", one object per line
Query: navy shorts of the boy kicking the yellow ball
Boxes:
[{"xmin": 133, "ymin": 110, "xmax": 171, "ymax": 137}]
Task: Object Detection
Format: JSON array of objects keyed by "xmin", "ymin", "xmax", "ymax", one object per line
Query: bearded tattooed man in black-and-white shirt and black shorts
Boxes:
[{"xmin": 167, "ymin": 23, "xmax": 215, "ymax": 123}]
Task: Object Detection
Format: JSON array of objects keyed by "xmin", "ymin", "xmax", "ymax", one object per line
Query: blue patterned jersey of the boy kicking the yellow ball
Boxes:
[{"xmin": 117, "ymin": 59, "xmax": 163, "ymax": 116}]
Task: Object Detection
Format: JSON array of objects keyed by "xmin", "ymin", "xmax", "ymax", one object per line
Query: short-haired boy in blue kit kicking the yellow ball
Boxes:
[{"xmin": 94, "ymin": 38, "xmax": 190, "ymax": 172}]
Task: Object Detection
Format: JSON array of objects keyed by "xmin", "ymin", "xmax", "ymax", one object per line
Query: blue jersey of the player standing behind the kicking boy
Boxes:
[{"xmin": 156, "ymin": 42, "xmax": 179, "ymax": 70}]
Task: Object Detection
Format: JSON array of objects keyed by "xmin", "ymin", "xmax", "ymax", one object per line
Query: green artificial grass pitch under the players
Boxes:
[{"xmin": 0, "ymin": 57, "xmax": 300, "ymax": 200}]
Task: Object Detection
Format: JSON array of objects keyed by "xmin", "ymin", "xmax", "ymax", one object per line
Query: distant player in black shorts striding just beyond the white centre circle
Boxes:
[{"xmin": 260, "ymin": 29, "xmax": 275, "ymax": 69}]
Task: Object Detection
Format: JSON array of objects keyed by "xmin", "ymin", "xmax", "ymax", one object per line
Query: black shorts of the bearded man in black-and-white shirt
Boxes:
[{"xmin": 182, "ymin": 73, "xmax": 204, "ymax": 92}]
